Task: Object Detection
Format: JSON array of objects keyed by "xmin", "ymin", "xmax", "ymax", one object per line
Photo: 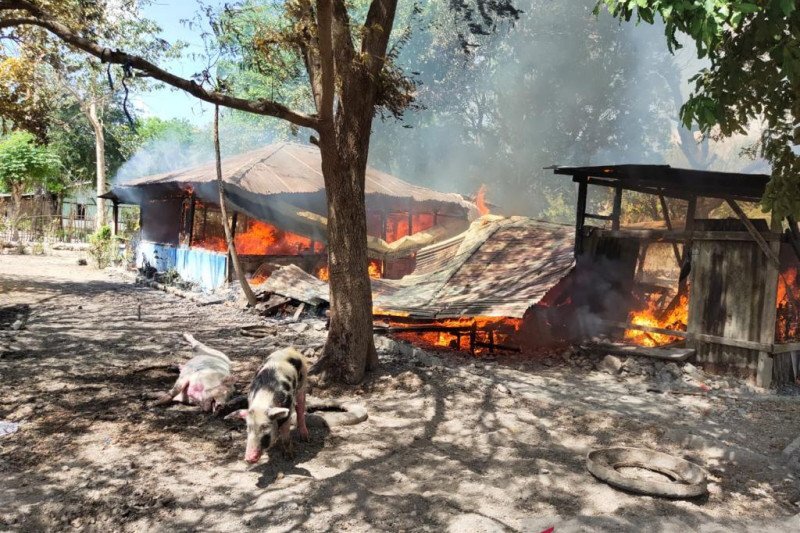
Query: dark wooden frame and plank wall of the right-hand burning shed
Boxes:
[{"xmin": 553, "ymin": 165, "xmax": 800, "ymax": 387}]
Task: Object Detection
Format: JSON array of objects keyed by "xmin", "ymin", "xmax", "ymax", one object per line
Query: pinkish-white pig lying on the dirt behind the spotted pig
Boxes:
[{"xmin": 154, "ymin": 333, "xmax": 236, "ymax": 411}]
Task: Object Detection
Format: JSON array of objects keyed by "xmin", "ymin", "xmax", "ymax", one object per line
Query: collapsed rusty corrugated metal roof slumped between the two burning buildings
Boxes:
[{"xmin": 260, "ymin": 216, "xmax": 575, "ymax": 320}]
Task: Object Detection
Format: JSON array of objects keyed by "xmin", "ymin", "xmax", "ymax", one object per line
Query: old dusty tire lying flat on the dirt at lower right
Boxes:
[{"xmin": 586, "ymin": 448, "xmax": 708, "ymax": 498}]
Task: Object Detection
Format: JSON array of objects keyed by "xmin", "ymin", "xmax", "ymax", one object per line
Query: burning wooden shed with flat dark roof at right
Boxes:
[{"xmin": 554, "ymin": 165, "xmax": 800, "ymax": 387}]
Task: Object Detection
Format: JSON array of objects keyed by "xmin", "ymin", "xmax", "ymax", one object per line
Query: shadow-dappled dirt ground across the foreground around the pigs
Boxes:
[{"xmin": 0, "ymin": 254, "xmax": 800, "ymax": 532}]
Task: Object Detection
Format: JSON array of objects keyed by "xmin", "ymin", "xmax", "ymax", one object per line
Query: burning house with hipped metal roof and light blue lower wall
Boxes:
[{"xmin": 100, "ymin": 143, "xmax": 478, "ymax": 289}]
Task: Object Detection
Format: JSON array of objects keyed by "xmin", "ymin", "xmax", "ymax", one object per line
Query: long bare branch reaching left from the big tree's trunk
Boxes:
[{"xmin": 0, "ymin": 8, "xmax": 319, "ymax": 129}]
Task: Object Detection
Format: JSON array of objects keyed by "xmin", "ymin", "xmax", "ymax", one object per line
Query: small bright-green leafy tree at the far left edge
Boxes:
[{"xmin": 0, "ymin": 132, "xmax": 61, "ymax": 240}]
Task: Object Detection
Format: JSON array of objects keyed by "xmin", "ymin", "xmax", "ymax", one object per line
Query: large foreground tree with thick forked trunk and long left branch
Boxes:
[{"xmin": 0, "ymin": 0, "xmax": 519, "ymax": 383}]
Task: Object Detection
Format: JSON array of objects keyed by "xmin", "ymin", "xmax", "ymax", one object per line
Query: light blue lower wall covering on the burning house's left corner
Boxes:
[{"xmin": 136, "ymin": 241, "xmax": 228, "ymax": 290}]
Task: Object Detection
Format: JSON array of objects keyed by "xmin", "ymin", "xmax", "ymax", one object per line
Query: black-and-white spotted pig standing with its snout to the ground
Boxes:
[{"xmin": 228, "ymin": 348, "xmax": 308, "ymax": 463}]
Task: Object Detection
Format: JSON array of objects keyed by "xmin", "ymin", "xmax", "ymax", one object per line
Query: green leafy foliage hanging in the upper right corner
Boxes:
[{"xmin": 601, "ymin": 0, "xmax": 800, "ymax": 216}]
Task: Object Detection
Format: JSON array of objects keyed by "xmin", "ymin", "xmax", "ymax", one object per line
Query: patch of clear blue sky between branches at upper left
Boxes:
[{"xmin": 135, "ymin": 0, "xmax": 228, "ymax": 124}]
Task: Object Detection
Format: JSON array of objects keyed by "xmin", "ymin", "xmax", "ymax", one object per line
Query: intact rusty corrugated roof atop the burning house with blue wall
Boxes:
[{"xmin": 121, "ymin": 143, "xmax": 472, "ymax": 209}]
